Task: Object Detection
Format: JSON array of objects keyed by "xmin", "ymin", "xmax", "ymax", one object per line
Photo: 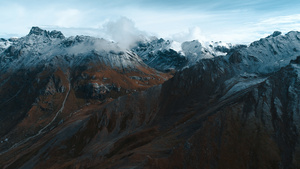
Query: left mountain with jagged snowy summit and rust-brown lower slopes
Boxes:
[{"xmin": 0, "ymin": 27, "xmax": 170, "ymax": 156}]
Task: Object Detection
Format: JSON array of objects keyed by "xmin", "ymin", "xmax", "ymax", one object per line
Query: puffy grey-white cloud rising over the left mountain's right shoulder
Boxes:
[{"xmin": 103, "ymin": 17, "xmax": 147, "ymax": 49}]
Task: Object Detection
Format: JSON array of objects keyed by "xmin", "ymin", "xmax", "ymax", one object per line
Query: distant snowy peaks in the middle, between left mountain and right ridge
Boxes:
[{"xmin": 132, "ymin": 38, "xmax": 233, "ymax": 71}]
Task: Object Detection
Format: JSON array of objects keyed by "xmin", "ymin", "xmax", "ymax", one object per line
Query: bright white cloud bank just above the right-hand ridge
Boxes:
[{"xmin": 195, "ymin": 14, "xmax": 300, "ymax": 44}]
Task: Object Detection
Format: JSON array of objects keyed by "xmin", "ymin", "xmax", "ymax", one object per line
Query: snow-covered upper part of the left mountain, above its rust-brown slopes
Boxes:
[{"xmin": 0, "ymin": 27, "xmax": 143, "ymax": 70}]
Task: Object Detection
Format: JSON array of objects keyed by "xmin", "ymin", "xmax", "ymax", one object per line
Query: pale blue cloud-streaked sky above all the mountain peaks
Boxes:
[{"xmin": 0, "ymin": 0, "xmax": 300, "ymax": 43}]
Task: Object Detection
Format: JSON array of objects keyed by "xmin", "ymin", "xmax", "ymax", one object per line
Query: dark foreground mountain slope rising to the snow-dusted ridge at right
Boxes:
[{"xmin": 0, "ymin": 29, "xmax": 300, "ymax": 169}]
